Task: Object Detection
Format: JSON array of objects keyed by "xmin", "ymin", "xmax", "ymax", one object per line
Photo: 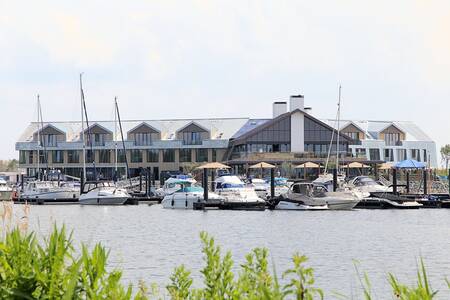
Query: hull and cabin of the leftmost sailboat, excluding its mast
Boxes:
[{"xmin": 20, "ymin": 181, "xmax": 80, "ymax": 201}]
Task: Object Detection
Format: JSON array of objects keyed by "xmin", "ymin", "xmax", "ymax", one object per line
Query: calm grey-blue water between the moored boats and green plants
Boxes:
[{"xmin": 17, "ymin": 205, "xmax": 450, "ymax": 299}]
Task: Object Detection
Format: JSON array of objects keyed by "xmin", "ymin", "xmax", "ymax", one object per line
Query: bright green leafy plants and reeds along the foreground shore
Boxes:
[{"xmin": 0, "ymin": 202, "xmax": 450, "ymax": 300}]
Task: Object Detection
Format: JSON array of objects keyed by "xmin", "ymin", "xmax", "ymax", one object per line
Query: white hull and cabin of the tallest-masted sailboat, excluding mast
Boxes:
[{"xmin": 79, "ymin": 181, "xmax": 131, "ymax": 205}]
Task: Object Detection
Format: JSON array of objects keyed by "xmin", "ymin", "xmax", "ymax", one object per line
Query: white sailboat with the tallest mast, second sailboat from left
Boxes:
[{"xmin": 79, "ymin": 74, "xmax": 131, "ymax": 205}]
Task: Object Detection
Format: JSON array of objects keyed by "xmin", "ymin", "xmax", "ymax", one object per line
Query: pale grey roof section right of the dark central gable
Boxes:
[{"xmin": 321, "ymin": 119, "xmax": 433, "ymax": 142}]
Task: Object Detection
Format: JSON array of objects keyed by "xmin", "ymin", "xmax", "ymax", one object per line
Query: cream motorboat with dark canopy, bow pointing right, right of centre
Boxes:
[{"xmin": 281, "ymin": 182, "xmax": 360, "ymax": 210}]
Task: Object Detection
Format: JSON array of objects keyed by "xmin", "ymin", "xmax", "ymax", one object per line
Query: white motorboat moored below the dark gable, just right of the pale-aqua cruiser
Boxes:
[{"xmin": 214, "ymin": 175, "xmax": 265, "ymax": 204}]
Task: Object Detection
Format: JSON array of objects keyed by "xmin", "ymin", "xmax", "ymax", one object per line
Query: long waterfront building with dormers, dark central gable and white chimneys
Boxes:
[{"xmin": 16, "ymin": 95, "xmax": 437, "ymax": 179}]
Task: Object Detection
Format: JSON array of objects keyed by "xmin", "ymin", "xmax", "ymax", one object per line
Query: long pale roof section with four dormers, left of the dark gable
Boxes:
[{"xmin": 18, "ymin": 118, "xmax": 249, "ymax": 142}]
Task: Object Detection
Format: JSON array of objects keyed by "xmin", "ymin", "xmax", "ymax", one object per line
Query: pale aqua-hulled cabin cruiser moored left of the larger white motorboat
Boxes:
[{"xmin": 161, "ymin": 179, "xmax": 221, "ymax": 209}]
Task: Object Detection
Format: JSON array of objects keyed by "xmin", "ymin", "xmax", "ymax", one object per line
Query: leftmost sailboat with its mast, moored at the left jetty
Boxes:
[{"xmin": 20, "ymin": 95, "xmax": 80, "ymax": 202}]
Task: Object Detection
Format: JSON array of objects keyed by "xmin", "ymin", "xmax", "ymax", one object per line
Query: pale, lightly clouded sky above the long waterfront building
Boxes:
[{"xmin": 0, "ymin": 0, "xmax": 450, "ymax": 163}]
